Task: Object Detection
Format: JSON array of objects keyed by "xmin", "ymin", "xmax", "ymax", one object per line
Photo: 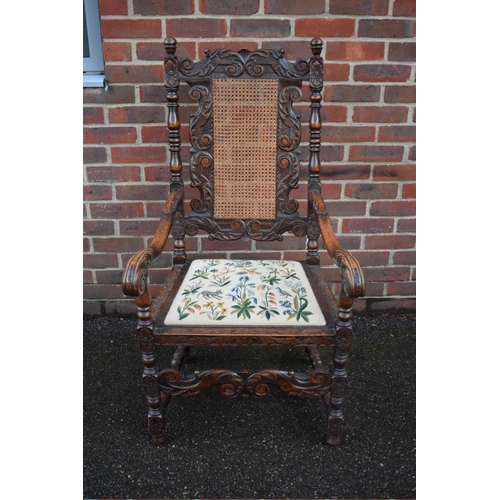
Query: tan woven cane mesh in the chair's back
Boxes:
[{"xmin": 212, "ymin": 79, "xmax": 278, "ymax": 219}]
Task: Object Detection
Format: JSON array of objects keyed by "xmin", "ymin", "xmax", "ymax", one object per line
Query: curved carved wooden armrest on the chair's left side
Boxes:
[{"xmin": 122, "ymin": 189, "xmax": 180, "ymax": 297}]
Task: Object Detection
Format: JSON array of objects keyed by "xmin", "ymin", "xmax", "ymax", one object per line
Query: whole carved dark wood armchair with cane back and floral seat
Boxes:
[{"xmin": 122, "ymin": 37, "xmax": 365, "ymax": 445}]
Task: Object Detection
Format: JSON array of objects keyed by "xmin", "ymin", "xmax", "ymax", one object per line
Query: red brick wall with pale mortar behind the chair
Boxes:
[{"xmin": 83, "ymin": 0, "xmax": 416, "ymax": 314}]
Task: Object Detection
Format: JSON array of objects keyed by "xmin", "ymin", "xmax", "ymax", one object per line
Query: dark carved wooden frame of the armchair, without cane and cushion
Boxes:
[{"xmin": 122, "ymin": 37, "xmax": 365, "ymax": 446}]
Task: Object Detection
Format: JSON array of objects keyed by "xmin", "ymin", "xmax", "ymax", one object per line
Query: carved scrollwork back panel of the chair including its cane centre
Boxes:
[{"xmin": 165, "ymin": 49, "xmax": 316, "ymax": 240}]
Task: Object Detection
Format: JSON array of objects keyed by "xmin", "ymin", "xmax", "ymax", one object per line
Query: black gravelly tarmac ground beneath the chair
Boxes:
[{"xmin": 83, "ymin": 314, "xmax": 416, "ymax": 499}]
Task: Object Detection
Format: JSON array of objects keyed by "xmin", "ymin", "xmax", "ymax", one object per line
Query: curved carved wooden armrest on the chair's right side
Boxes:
[{"xmin": 310, "ymin": 191, "xmax": 366, "ymax": 299}]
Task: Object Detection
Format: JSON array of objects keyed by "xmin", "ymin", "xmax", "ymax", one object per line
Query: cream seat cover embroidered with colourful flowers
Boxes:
[{"xmin": 165, "ymin": 259, "xmax": 326, "ymax": 326}]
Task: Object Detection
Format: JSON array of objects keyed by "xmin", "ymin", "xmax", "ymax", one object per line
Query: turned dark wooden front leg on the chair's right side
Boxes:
[{"xmin": 325, "ymin": 297, "xmax": 353, "ymax": 446}]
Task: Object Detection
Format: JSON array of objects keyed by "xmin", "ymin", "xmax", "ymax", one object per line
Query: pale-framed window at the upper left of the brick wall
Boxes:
[{"xmin": 83, "ymin": 0, "xmax": 104, "ymax": 87}]
